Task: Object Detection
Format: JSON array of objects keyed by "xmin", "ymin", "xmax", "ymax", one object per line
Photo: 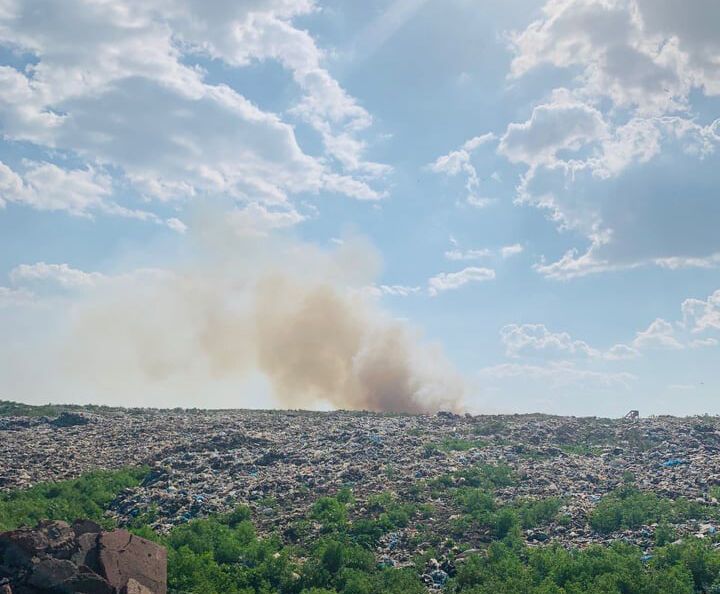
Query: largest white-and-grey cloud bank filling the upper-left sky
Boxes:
[{"xmin": 0, "ymin": 0, "xmax": 389, "ymax": 229}]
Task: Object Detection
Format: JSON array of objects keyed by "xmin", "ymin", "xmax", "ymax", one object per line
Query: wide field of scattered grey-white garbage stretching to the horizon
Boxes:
[{"xmin": 0, "ymin": 409, "xmax": 720, "ymax": 556}]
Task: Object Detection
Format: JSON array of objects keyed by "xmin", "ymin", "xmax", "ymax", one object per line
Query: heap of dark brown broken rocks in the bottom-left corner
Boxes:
[{"xmin": 0, "ymin": 520, "xmax": 167, "ymax": 594}]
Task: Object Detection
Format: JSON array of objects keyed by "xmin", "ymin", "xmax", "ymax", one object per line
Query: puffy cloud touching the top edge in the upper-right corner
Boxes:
[{"xmin": 511, "ymin": 0, "xmax": 720, "ymax": 113}]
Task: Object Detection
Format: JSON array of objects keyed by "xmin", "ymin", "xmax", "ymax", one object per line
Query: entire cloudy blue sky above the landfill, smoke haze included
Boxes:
[{"xmin": 0, "ymin": 0, "xmax": 720, "ymax": 416}]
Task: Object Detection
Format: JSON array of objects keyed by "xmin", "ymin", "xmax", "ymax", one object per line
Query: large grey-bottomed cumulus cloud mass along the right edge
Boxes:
[{"xmin": 498, "ymin": 0, "xmax": 720, "ymax": 279}]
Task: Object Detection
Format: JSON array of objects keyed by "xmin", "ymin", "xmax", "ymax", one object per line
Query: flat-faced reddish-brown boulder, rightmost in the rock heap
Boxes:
[{"xmin": 100, "ymin": 530, "xmax": 167, "ymax": 594}]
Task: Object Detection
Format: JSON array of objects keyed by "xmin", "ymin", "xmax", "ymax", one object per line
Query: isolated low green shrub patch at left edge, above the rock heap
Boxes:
[{"xmin": 0, "ymin": 468, "xmax": 148, "ymax": 531}]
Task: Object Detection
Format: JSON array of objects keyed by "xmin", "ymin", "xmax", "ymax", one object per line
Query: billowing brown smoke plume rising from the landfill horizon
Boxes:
[{"xmin": 56, "ymin": 231, "xmax": 463, "ymax": 413}]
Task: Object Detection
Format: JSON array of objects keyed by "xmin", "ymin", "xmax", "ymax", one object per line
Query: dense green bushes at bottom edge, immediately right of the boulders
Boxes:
[{"xmin": 156, "ymin": 512, "xmax": 424, "ymax": 594}]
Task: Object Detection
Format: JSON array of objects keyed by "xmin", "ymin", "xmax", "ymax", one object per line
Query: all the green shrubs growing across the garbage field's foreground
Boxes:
[{"xmin": 11, "ymin": 465, "xmax": 720, "ymax": 594}]
